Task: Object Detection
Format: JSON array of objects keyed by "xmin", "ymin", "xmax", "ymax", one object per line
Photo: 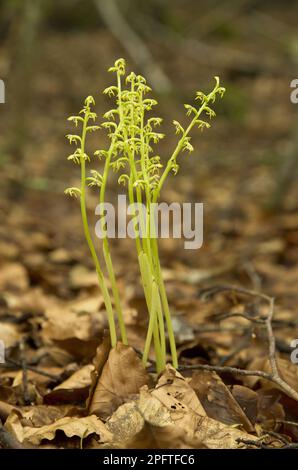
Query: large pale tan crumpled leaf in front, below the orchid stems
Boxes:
[{"xmin": 106, "ymin": 387, "xmax": 256, "ymax": 449}]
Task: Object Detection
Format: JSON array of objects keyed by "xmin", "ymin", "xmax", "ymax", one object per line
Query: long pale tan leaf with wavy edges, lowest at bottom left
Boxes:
[{"xmin": 5, "ymin": 412, "xmax": 113, "ymax": 445}]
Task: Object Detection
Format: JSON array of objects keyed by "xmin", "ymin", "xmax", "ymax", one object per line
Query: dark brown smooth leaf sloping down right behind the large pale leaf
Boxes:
[{"xmin": 190, "ymin": 371, "xmax": 254, "ymax": 432}]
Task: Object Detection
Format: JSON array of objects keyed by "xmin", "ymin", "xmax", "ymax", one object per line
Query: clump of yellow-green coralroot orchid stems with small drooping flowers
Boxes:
[{"xmin": 65, "ymin": 59, "xmax": 225, "ymax": 372}]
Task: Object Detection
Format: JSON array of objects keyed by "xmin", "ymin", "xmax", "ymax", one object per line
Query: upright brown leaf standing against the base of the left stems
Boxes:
[{"xmin": 89, "ymin": 343, "xmax": 148, "ymax": 418}]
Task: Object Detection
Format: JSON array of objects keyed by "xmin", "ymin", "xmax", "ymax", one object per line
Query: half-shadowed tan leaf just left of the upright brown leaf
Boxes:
[{"xmin": 44, "ymin": 364, "xmax": 94, "ymax": 404}]
